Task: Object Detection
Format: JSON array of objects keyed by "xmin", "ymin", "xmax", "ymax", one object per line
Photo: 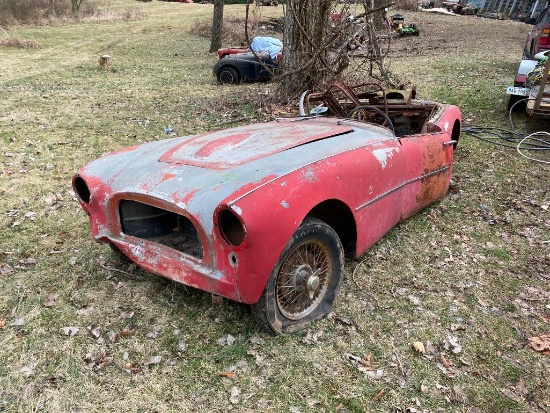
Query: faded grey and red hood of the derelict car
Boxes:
[{"xmin": 79, "ymin": 120, "xmax": 395, "ymax": 229}]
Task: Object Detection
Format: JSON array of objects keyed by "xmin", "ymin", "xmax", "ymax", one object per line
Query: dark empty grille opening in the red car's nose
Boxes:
[{"xmin": 119, "ymin": 201, "xmax": 203, "ymax": 259}]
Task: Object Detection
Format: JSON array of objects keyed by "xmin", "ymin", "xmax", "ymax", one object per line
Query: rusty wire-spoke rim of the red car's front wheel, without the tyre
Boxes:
[{"xmin": 276, "ymin": 241, "xmax": 332, "ymax": 320}]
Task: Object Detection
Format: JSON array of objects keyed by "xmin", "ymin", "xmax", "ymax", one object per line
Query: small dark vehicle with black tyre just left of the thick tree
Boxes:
[{"xmin": 212, "ymin": 51, "xmax": 279, "ymax": 84}]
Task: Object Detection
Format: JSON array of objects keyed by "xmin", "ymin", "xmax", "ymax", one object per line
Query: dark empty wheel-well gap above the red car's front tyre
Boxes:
[{"xmin": 307, "ymin": 199, "xmax": 357, "ymax": 256}]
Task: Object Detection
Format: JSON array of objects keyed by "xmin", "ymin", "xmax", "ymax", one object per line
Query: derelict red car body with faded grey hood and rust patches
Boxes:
[{"xmin": 73, "ymin": 98, "xmax": 461, "ymax": 333}]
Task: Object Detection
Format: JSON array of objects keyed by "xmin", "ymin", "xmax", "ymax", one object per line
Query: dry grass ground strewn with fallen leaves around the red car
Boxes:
[{"xmin": 0, "ymin": 0, "xmax": 550, "ymax": 412}]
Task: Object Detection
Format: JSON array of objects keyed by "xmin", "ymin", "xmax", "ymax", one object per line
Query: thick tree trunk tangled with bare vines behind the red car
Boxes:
[{"xmin": 279, "ymin": 0, "xmax": 396, "ymax": 100}]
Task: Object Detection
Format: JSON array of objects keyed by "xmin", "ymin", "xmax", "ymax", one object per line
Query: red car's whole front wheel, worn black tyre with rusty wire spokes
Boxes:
[{"xmin": 252, "ymin": 218, "xmax": 344, "ymax": 334}]
